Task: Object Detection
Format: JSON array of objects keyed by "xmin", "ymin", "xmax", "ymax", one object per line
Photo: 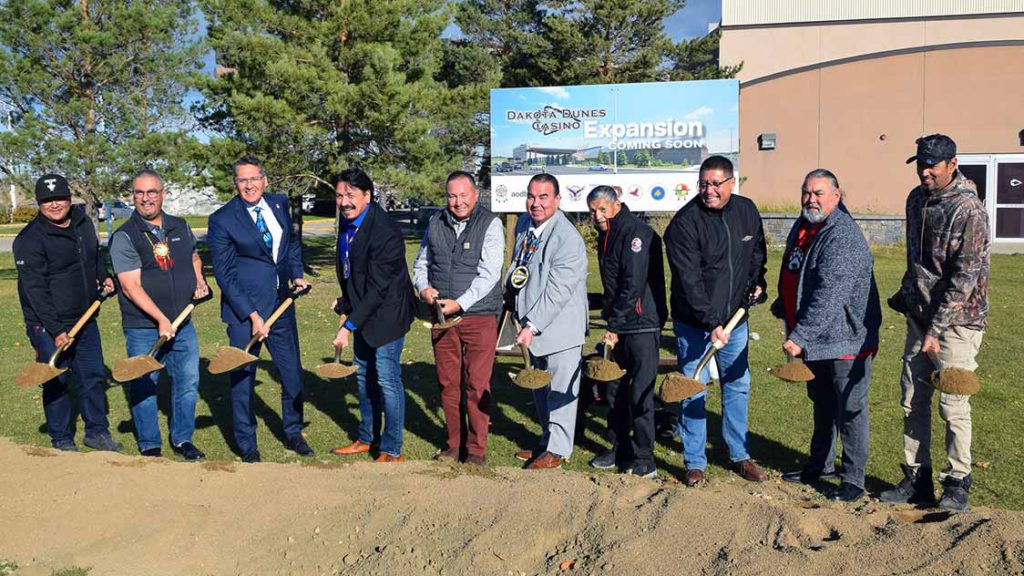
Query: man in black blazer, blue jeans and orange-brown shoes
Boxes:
[{"xmin": 332, "ymin": 168, "xmax": 416, "ymax": 462}]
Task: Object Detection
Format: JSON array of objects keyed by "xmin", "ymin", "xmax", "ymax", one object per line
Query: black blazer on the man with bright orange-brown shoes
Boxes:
[{"xmin": 335, "ymin": 202, "xmax": 416, "ymax": 347}]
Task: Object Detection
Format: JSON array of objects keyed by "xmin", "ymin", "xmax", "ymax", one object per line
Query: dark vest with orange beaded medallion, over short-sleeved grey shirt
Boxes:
[{"xmin": 114, "ymin": 212, "xmax": 196, "ymax": 328}]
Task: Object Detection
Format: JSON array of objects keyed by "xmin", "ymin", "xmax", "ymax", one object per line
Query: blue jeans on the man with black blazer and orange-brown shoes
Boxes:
[{"xmin": 352, "ymin": 330, "xmax": 406, "ymax": 456}]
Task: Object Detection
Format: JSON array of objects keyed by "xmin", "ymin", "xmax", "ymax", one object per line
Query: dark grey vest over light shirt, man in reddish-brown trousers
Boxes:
[{"xmin": 427, "ymin": 204, "xmax": 502, "ymax": 316}]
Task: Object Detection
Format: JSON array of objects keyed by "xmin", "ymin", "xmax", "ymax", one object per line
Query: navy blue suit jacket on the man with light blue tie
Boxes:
[{"xmin": 206, "ymin": 194, "xmax": 302, "ymax": 325}]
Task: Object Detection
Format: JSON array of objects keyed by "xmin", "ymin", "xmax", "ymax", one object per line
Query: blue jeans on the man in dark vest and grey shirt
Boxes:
[{"xmin": 124, "ymin": 322, "xmax": 199, "ymax": 451}]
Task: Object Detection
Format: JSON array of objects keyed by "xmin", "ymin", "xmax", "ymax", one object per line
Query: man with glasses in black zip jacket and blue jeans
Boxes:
[{"xmin": 665, "ymin": 156, "xmax": 767, "ymax": 486}]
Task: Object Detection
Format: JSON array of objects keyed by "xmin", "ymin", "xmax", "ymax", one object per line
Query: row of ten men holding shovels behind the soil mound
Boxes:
[{"xmin": 15, "ymin": 134, "xmax": 988, "ymax": 508}]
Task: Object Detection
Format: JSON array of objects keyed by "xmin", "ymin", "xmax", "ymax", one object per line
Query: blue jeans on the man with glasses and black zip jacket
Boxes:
[{"xmin": 673, "ymin": 322, "xmax": 751, "ymax": 470}]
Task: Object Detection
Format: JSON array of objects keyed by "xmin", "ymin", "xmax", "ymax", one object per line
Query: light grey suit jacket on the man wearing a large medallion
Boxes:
[{"xmin": 505, "ymin": 210, "xmax": 589, "ymax": 356}]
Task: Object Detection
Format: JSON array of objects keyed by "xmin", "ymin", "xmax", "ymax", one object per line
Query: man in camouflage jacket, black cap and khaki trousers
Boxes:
[{"xmin": 881, "ymin": 134, "xmax": 989, "ymax": 510}]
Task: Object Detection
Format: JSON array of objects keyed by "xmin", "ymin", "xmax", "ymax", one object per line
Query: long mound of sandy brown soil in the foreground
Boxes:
[{"xmin": 0, "ymin": 440, "xmax": 1024, "ymax": 576}]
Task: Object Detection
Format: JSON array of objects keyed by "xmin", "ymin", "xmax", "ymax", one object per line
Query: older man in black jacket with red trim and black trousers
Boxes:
[{"xmin": 587, "ymin": 186, "xmax": 668, "ymax": 478}]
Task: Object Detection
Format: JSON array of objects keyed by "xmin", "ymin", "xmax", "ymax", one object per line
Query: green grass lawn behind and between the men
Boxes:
[{"xmin": 0, "ymin": 239, "xmax": 1024, "ymax": 509}]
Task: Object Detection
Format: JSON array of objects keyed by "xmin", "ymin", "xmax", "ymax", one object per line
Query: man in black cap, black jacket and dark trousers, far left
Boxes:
[{"xmin": 14, "ymin": 174, "xmax": 122, "ymax": 452}]
